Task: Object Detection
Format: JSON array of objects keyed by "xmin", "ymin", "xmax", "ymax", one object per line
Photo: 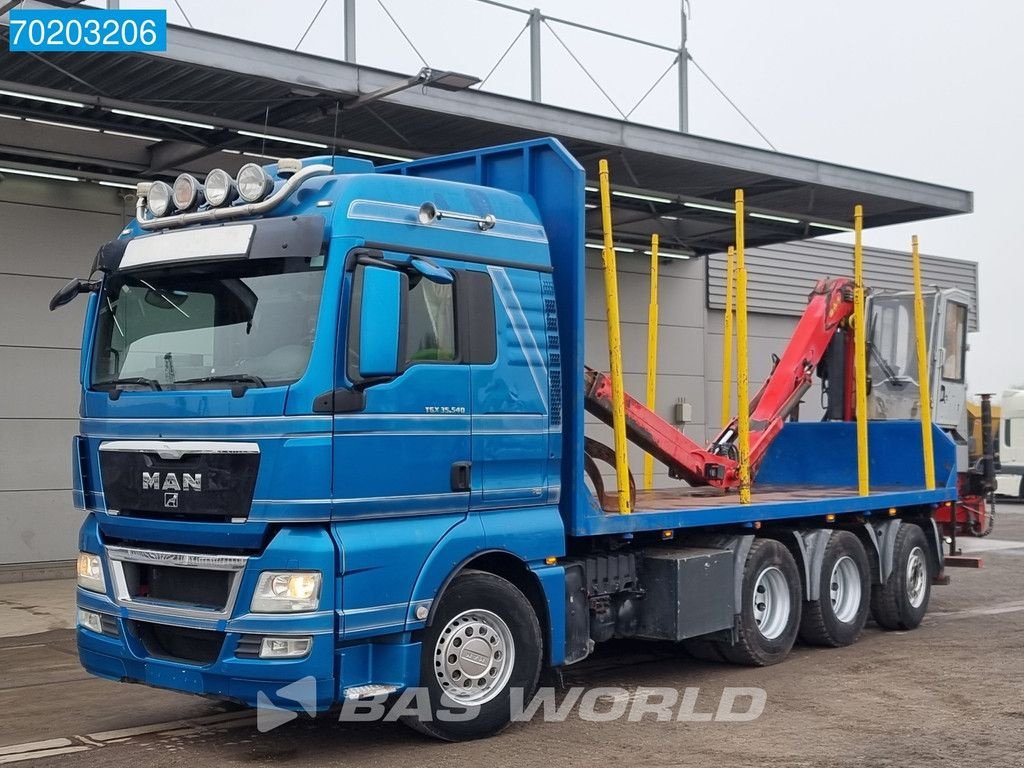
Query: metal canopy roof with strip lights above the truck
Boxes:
[{"xmin": 0, "ymin": 20, "xmax": 973, "ymax": 253}]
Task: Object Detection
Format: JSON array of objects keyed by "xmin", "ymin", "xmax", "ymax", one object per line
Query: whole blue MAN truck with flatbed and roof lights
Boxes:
[{"xmin": 51, "ymin": 139, "xmax": 956, "ymax": 740}]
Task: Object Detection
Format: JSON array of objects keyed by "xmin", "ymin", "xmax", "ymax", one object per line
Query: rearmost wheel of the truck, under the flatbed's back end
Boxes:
[{"xmin": 871, "ymin": 523, "xmax": 932, "ymax": 631}]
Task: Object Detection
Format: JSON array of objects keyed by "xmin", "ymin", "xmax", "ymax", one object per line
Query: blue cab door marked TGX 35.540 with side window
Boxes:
[{"xmin": 333, "ymin": 259, "xmax": 471, "ymax": 519}]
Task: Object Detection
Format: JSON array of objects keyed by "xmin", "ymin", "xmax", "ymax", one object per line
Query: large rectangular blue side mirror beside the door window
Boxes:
[{"xmin": 359, "ymin": 266, "xmax": 409, "ymax": 379}]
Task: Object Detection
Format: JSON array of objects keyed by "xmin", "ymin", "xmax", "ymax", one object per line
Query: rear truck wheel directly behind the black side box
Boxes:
[{"xmin": 719, "ymin": 539, "xmax": 803, "ymax": 667}]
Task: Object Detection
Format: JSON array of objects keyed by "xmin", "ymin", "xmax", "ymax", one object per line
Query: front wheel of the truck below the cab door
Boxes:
[{"xmin": 402, "ymin": 570, "xmax": 544, "ymax": 741}]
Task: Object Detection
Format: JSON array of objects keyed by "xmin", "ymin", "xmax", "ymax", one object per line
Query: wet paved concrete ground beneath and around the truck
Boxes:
[{"xmin": 0, "ymin": 505, "xmax": 1024, "ymax": 768}]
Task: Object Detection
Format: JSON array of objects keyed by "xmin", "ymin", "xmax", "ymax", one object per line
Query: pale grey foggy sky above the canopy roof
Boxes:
[{"xmin": 140, "ymin": 0, "xmax": 1024, "ymax": 392}]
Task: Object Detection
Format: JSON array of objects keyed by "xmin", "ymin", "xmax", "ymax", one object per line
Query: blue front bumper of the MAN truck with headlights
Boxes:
[{"xmin": 77, "ymin": 517, "xmax": 338, "ymax": 711}]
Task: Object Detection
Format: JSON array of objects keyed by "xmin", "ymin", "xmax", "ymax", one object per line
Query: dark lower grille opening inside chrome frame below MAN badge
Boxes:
[{"xmin": 122, "ymin": 562, "xmax": 233, "ymax": 610}]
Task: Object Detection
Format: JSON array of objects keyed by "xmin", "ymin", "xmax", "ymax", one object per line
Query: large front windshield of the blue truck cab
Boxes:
[{"xmin": 92, "ymin": 256, "xmax": 324, "ymax": 389}]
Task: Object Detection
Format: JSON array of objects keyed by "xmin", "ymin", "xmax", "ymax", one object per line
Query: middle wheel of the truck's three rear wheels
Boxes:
[{"xmin": 800, "ymin": 530, "xmax": 871, "ymax": 648}]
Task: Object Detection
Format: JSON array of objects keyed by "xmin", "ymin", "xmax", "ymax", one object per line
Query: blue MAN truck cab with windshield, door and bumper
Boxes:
[{"xmin": 73, "ymin": 145, "xmax": 564, "ymax": 733}]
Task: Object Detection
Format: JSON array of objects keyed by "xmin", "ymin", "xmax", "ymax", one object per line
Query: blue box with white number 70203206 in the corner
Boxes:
[{"xmin": 9, "ymin": 8, "xmax": 167, "ymax": 52}]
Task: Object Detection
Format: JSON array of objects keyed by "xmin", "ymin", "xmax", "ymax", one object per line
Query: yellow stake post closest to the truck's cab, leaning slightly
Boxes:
[{"xmin": 598, "ymin": 160, "xmax": 633, "ymax": 515}]
